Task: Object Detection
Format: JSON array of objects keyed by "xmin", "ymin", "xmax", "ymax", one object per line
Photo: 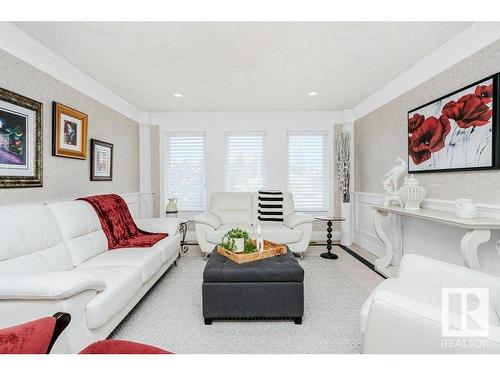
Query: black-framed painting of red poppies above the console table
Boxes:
[{"xmin": 408, "ymin": 74, "xmax": 500, "ymax": 173}]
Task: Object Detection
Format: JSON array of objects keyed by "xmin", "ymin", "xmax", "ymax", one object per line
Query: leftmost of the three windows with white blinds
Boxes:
[{"xmin": 165, "ymin": 134, "xmax": 205, "ymax": 211}]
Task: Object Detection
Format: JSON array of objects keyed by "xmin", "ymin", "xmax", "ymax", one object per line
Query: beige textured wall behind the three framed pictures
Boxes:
[{"xmin": 0, "ymin": 50, "xmax": 139, "ymax": 204}]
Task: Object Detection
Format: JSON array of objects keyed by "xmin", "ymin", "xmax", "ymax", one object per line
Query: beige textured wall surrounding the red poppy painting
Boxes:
[{"xmin": 354, "ymin": 41, "xmax": 500, "ymax": 204}]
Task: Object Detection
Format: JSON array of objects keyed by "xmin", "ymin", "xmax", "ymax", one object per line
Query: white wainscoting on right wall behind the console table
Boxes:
[{"xmin": 353, "ymin": 192, "xmax": 500, "ymax": 275}]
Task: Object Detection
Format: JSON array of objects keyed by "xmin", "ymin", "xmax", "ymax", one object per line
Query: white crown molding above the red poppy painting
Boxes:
[{"xmin": 353, "ymin": 22, "xmax": 500, "ymax": 119}]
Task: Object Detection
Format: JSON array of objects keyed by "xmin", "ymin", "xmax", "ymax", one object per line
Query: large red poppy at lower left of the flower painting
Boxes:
[{"xmin": 408, "ymin": 116, "xmax": 451, "ymax": 165}]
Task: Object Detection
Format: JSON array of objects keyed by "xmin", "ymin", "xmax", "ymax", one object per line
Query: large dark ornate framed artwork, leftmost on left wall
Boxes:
[{"xmin": 0, "ymin": 88, "xmax": 43, "ymax": 188}]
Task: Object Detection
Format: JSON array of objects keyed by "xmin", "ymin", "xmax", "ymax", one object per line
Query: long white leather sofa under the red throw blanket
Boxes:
[{"xmin": 0, "ymin": 201, "xmax": 180, "ymax": 353}]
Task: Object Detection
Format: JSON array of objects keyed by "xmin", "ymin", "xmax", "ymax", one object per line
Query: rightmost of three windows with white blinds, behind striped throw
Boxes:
[{"xmin": 287, "ymin": 134, "xmax": 329, "ymax": 211}]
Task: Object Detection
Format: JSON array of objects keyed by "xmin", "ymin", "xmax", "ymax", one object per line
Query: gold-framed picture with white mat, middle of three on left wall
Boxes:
[{"xmin": 52, "ymin": 102, "xmax": 88, "ymax": 160}]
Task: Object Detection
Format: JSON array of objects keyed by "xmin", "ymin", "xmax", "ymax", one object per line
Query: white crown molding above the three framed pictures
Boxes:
[{"xmin": 0, "ymin": 22, "xmax": 140, "ymax": 121}]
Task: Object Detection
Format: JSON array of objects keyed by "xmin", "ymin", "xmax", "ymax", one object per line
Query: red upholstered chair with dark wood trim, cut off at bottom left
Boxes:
[{"xmin": 0, "ymin": 312, "xmax": 173, "ymax": 354}]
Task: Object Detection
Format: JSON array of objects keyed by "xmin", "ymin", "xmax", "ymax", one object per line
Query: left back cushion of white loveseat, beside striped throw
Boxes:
[{"xmin": 209, "ymin": 192, "xmax": 253, "ymax": 224}]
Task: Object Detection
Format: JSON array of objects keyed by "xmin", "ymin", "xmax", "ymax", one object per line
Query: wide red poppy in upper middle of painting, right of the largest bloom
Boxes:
[{"xmin": 443, "ymin": 94, "xmax": 493, "ymax": 129}]
